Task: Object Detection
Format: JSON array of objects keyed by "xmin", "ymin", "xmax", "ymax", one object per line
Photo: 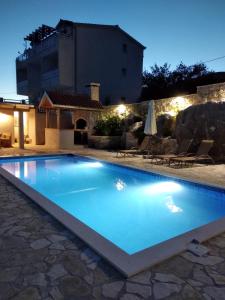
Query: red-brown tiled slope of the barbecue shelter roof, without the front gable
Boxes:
[{"xmin": 47, "ymin": 92, "xmax": 103, "ymax": 109}]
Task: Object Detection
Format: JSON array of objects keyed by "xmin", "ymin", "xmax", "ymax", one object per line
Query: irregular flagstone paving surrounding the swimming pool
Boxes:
[{"xmin": 0, "ymin": 147, "xmax": 225, "ymax": 300}]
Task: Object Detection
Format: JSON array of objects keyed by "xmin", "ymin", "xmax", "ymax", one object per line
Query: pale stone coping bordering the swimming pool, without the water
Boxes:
[{"xmin": 0, "ymin": 154, "xmax": 225, "ymax": 277}]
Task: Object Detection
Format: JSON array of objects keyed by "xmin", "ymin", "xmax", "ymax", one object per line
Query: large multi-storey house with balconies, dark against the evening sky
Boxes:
[{"xmin": 16, "ymin": 20, "xmax": 145, "ymax": 104}]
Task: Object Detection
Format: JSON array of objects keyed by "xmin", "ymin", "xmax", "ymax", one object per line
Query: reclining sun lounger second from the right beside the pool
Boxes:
[{"xmin": 151, "ymin": 139, "xmax": 193, "ymax": 164}]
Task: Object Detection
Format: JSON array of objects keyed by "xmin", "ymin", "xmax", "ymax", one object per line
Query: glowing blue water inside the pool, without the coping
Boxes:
[{"xmin": 0, "ymin": 155, "xmax": 225, "ymax": 254}]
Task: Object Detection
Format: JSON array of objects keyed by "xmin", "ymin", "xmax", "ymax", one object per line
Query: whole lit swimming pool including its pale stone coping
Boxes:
[{"xmin": 0, "ymin": 155, "xmax": 225, "ymax": 276}]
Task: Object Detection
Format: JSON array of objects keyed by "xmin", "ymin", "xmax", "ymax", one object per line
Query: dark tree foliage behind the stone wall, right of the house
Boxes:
[{"xmin": 140, "ymin": 62, "xmax": 225, "ymax": 101}]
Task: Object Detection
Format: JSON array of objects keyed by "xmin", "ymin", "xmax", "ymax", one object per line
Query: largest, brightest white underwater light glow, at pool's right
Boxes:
[{"xmin": 144, "ymin": 181, "xmax": 182, "ymax": 195}]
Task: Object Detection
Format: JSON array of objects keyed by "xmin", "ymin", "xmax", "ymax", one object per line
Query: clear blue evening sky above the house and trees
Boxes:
[{"xmin": 0, "ymin": 0, "xmax": 225, "ymax": 98}]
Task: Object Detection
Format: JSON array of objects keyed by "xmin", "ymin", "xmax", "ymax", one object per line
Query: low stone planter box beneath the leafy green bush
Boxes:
[{"xmin": 88, "ymin": 135, "xmax": 121, "ymax": 149}]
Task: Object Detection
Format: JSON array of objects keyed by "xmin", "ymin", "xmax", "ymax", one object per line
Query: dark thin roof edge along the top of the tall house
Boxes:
[{"xmin": 55, "ymin": 19, "xmax": 146, "ymax": 49}]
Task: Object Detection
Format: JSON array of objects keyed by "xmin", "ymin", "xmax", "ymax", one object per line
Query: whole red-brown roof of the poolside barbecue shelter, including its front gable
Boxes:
[{"xmin": 39, "ymin": 92, "xmax": 103, "ymax": 109}]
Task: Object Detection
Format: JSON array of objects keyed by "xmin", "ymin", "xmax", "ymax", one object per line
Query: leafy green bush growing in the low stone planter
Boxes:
[{"xmin": 94, "ymin": 115, "xmax": 123, "ymax": 136}]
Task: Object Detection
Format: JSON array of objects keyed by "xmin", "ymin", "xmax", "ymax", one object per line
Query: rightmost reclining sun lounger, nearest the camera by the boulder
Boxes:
[{"xmin": 170, "ymin": 140, "xmax": 215, "ymax": 167}]
